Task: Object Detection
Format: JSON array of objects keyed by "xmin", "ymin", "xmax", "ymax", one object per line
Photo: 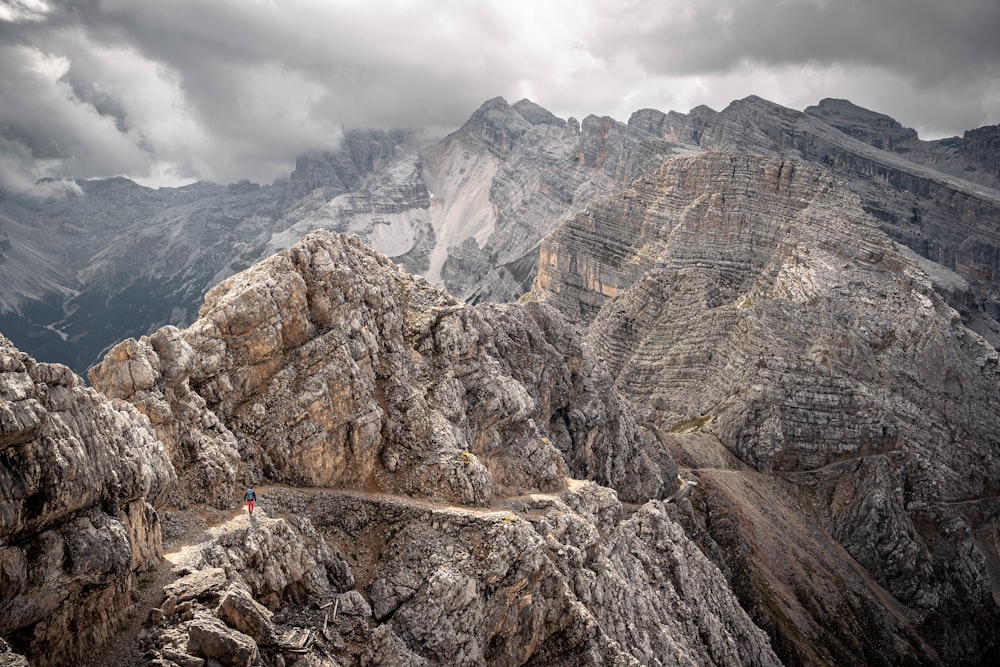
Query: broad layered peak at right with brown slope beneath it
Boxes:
[{"xmin": 537, "ymin": 154, "xmax": 1000, "ymax": 664}]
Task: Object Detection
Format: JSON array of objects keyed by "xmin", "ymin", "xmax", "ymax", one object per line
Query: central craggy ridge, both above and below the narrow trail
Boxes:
[{"xmin": 82, "ymin": 232, "xmax": 779, "ymax": 666}]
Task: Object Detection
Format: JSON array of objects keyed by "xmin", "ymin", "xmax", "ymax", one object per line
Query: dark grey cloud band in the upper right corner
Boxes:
[{"xmin": 605, "ymin": 0, "xmax": 1000, "ymax": 85}]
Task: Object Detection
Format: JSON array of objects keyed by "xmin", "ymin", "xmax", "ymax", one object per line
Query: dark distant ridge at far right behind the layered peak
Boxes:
[{"xmin": 629, "ymin": 96, "xmax": 1000, "ymax": 336}]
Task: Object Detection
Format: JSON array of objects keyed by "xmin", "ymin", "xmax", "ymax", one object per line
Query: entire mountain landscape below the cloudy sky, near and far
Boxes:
[{"xmin": 0, "ymin": 97, "xmax": 1000, "ymax": 667}]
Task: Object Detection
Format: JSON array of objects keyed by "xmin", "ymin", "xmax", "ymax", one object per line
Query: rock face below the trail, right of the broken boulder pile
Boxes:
[{"xmin": 252, "ymin": 483, "xmax": 779, "ymax": 665}]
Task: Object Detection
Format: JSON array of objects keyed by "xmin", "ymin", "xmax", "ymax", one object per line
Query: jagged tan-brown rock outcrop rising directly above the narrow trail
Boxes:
[{"xmin": 90, "ymin": 232, "xmax": 676, "ymax": 506}]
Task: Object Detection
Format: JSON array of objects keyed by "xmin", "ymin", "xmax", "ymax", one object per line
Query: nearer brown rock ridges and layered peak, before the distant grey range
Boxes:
[{"xmin": 0, "ymin": 145, "xmax": 1000, "ymax": 665}]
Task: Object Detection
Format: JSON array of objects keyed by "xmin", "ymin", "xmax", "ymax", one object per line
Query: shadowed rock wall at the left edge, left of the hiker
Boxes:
[{"xmin": 0, "ymin": 336, "xmax": 174, "ymax": 665}]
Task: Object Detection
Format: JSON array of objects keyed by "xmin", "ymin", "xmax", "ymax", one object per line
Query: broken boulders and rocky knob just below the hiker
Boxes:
[{"xmin": 142, "ymin": 516, "xmax": 354, "ymax": 665}]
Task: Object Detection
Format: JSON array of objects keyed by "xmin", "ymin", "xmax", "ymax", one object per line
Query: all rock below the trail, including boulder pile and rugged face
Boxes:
[{"xmin": 145, "ymin": 482, "xmax": 779, "ymax": 667}]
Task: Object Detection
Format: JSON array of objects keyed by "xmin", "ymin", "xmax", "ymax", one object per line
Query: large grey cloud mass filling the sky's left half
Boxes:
[{"xmin": 0, "ymin": 0, "xmax": 540, "ymax": 188}]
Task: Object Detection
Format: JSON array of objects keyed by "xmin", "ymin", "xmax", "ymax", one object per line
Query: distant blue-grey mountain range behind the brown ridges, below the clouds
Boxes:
[{"xmin": 0, "ymin": 98, "xmax": 1000, "ymax": 373}]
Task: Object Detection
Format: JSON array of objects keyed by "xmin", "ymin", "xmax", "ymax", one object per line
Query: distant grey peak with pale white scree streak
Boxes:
[{"xmin": 268, "ymin": 97, "xmax": 686, "ymax": 302}]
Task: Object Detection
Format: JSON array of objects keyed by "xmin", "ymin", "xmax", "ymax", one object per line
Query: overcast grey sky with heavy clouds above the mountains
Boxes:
[{"xmin": 0, "ymin": 0, "xmax": 1000, "ymax": 190}]
